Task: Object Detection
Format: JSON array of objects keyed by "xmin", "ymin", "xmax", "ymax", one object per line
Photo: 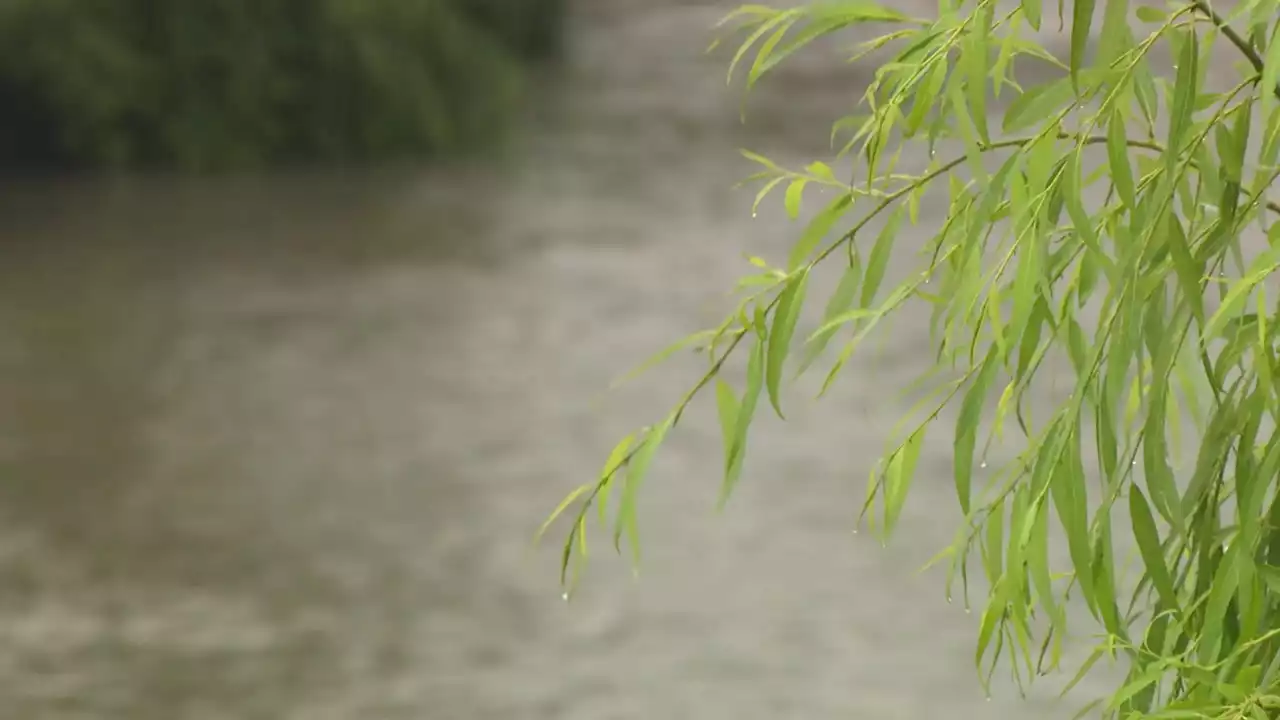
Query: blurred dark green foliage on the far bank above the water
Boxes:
[{"xmin": 0, "ymin": 0, "xmax": 563, "ymax": 172}]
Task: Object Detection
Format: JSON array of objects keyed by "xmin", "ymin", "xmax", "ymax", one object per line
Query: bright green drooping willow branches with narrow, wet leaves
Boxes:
[{"xmin": 553, "ymin": 0, "xmax": 1280, "ymax": 720}]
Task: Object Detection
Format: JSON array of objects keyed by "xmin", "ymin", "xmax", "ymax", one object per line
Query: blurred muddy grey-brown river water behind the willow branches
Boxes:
[{"xmin": 0, "ymin": 0, "xmax": 1126, "ymax": 720}]
